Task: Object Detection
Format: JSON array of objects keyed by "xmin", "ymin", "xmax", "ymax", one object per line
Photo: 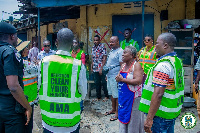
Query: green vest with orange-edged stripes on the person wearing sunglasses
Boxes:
[{"xmin": 139, "ymin": 46, "xmax": 157, "ymax": 74}]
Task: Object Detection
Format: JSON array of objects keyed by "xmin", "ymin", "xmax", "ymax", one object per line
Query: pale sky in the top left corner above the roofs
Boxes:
[{"xmin": 0, "ymin": 0, "xmax": 22, "ymax": 21}]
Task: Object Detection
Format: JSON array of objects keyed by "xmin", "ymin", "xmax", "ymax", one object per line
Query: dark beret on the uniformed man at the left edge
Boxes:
[{"xmin": 0, "ymin": 22, "xmax": 17, "ymax": 34}]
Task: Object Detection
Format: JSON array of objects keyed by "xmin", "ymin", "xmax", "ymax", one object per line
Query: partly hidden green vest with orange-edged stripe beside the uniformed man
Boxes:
[{"xmin": 23, "ymin": 77, "xmax": 37, "ymax": 103}]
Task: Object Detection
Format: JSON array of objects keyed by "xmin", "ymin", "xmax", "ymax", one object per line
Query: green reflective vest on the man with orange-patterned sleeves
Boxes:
[{"xmin": 139, "ymin": 56, "xmax": 184, "ymax": 119}]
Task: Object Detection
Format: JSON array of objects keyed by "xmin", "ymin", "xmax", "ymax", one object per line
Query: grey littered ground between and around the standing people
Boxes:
[{"xmin": 33, "ymin": 90, "xmax": 200, "ymax": 133}]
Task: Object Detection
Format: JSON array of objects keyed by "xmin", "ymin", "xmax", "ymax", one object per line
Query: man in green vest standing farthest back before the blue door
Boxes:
[{"xmin": 120, "ymin": 28, "xmax": 139, "ymax": 52}]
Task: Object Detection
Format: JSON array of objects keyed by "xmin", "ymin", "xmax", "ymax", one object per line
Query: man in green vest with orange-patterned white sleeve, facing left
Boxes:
[{"xmin": 139, "ymin": 33, "xmax": 184, "ymax": 133}]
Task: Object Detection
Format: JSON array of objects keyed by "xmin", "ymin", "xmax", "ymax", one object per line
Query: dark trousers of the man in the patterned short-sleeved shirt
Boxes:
[{"xmin": 94, "ymin": 72, "xmax": 109, "ymax": 99}]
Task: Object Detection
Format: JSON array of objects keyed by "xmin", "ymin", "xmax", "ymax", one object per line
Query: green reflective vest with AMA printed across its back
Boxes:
[{"xmin": 39, "ymin": 55, "xmax": 81, "ymax": 127}]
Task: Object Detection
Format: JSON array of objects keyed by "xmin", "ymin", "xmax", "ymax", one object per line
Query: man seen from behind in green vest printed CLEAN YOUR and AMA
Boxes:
[{"xmin": 38, "ymin": 28, "xmax": 87, "ymax": 133}]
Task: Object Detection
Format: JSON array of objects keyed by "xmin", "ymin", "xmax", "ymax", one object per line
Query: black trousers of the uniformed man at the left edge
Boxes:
[{"xmin": 0, "ymin": 95, "xmax": 25, "ymax": 133}]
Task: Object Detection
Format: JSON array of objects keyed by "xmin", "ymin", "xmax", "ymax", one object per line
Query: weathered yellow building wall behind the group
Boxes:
[{"xmin": 27, "ymin": 0, "xmax": 195, "ymax": 54}]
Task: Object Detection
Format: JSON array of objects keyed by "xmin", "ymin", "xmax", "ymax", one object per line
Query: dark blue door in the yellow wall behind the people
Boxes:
[{"xmin": 112, "ymin": 14, "xmax": 154, "ymax": 48}]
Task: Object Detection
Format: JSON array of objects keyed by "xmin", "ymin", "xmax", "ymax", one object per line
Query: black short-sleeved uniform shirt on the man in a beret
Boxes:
[{"xmin": 0, "ymin": 41, "xmax": 24, "ymax": 95}]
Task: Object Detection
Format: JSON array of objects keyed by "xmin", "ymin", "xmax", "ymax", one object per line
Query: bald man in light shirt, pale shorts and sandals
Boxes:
[{"xmin": 105, "ymin": 36, "xmax": 123, "ymax": 121}]
